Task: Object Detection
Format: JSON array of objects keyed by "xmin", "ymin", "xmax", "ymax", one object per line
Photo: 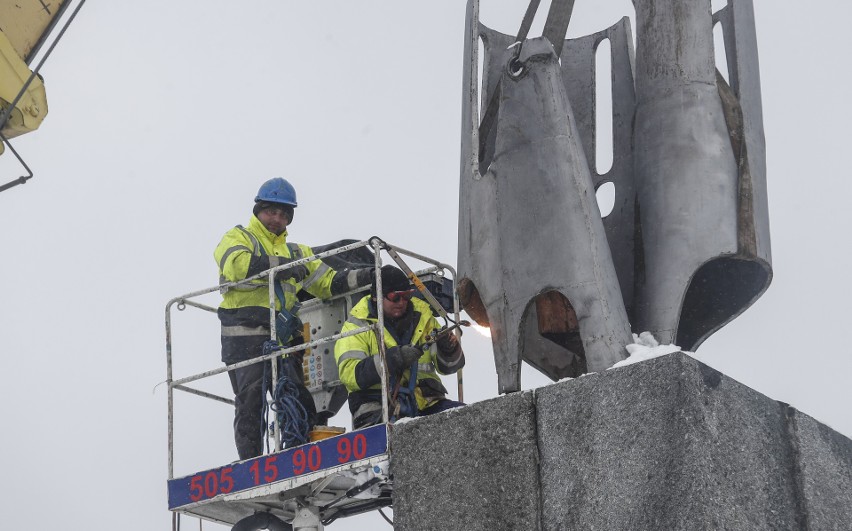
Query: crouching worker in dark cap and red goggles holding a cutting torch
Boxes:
[{"xmin": 334, "ymin": 265, "xmax": 465, "ymax": 429}]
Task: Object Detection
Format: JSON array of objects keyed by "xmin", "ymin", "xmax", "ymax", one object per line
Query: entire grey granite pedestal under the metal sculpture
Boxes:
[{"xmin": 391, "ymin": 353, "xmax": 852, "ymax": 531}]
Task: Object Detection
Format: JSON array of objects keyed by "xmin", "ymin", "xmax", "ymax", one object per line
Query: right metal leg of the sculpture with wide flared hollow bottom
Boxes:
[{"xmin": 633, "ymin": 0, "xmax": 772, "ymax": 350}]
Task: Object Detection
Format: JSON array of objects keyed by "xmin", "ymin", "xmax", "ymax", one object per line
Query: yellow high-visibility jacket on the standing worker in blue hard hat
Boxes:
[{"xmin": 213, "ymin": 216, "xmax": 335, "ymax": 328}]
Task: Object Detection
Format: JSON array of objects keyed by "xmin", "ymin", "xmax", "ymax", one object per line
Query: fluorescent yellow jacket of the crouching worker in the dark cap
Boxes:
[{"xmin": 334, "ymin": 295, "xmax": 450, "ymax": 410}]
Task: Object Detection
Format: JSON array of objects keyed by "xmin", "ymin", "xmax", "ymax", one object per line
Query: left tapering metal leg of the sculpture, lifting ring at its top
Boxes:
[{"xmin": 458, "ymin": 0, "xmax": 631, "ymax": 393}]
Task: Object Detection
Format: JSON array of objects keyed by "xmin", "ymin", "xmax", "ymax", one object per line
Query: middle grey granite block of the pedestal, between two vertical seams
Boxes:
[{"xmin": 536, "ymin": 354, "xmax": 801, "ymax": 530}]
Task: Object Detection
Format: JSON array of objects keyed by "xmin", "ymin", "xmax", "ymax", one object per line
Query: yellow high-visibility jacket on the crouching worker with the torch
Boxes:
[{"xmin": 334, "ymin": 295, "xmax": 464, "ymax": 415}]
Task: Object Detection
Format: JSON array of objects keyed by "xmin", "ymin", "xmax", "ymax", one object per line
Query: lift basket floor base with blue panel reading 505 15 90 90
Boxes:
[{"xmin": 168, "ymin": 424, "xmax": 391, "ymax": 525}]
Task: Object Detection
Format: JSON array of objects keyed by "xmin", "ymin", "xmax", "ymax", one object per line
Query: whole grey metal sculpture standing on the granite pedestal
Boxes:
[{"xmin": 458, "ymin": 0, "xmax": 772, "ymax": 392}]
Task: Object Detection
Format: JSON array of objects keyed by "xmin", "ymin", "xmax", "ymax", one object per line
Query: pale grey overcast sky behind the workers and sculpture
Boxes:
[{"xmin": 0, "ymin": 0, "xmax": 852, "ymax": 531}]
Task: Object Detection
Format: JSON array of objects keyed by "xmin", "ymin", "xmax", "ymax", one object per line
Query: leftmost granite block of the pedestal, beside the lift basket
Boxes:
[{"xmin": 391, "ymin": 392, "xmax": 540, "ymax": 531}]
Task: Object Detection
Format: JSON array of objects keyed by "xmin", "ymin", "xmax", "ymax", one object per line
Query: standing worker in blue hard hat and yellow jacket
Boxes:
[{"xmin": 213, "ymin": 177, "xmax": 372, "ymax": 459}]
